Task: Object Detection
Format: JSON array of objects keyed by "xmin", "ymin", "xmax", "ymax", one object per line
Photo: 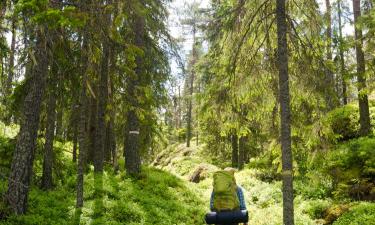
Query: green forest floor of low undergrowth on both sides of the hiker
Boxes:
[{"xmin": 0, "ymin": 127, "xmax": 375, "ymax": 225}]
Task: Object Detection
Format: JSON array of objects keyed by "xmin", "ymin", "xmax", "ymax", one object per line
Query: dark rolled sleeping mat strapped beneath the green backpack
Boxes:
[{"xmin": 205, "ymin": 210, "xmax": 249, "ymax": 224}]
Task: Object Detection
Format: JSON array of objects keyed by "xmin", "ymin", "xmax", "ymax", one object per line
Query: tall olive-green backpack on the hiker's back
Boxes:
[{"xmin": 213, "ymin": 171, "xmax": 240, "ymax": 211}]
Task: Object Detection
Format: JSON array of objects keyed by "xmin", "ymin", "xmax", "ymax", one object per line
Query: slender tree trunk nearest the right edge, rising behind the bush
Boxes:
[{"xmin": 353, "ymin": 0, "xmax": 371, "ymax": 136}]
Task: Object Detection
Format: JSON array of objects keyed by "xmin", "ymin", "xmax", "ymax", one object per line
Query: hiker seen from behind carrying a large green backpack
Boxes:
[{"xmin": 210, "ymin": 167, "xmax": 247, "ymax": 225}]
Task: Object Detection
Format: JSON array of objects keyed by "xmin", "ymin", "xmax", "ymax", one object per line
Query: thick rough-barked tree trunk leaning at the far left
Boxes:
[{"xmin": 6, "ymin": 27, "xmax": 48, "ymax": 214}]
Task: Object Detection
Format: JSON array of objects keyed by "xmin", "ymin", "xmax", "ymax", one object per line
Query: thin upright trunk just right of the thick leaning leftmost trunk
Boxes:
[{"xmin": 41, "ymin": 59, "xmax": 58, "ymax": 190}]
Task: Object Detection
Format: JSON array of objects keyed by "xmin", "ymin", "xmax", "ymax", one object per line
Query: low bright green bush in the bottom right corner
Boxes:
[{"xmin": 333, "ymin": 202, "xmax": 375, "ymax": 225}]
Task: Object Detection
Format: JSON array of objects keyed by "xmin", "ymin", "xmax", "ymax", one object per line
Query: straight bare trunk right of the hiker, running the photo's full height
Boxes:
[{"xmin": 276, "ymin": 0, "xmax": 294, "ymax": 225}]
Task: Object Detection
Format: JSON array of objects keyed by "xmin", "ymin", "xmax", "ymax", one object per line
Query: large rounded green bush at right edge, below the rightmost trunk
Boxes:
[{"xmin": 306, "ymin": 137, "xmax": 375, "ymax": 200}]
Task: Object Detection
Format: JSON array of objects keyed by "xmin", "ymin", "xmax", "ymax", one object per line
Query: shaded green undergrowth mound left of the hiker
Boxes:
[{"xmin": 0, "ymin": 168, "xmax": 205, "ymax": 225}]
